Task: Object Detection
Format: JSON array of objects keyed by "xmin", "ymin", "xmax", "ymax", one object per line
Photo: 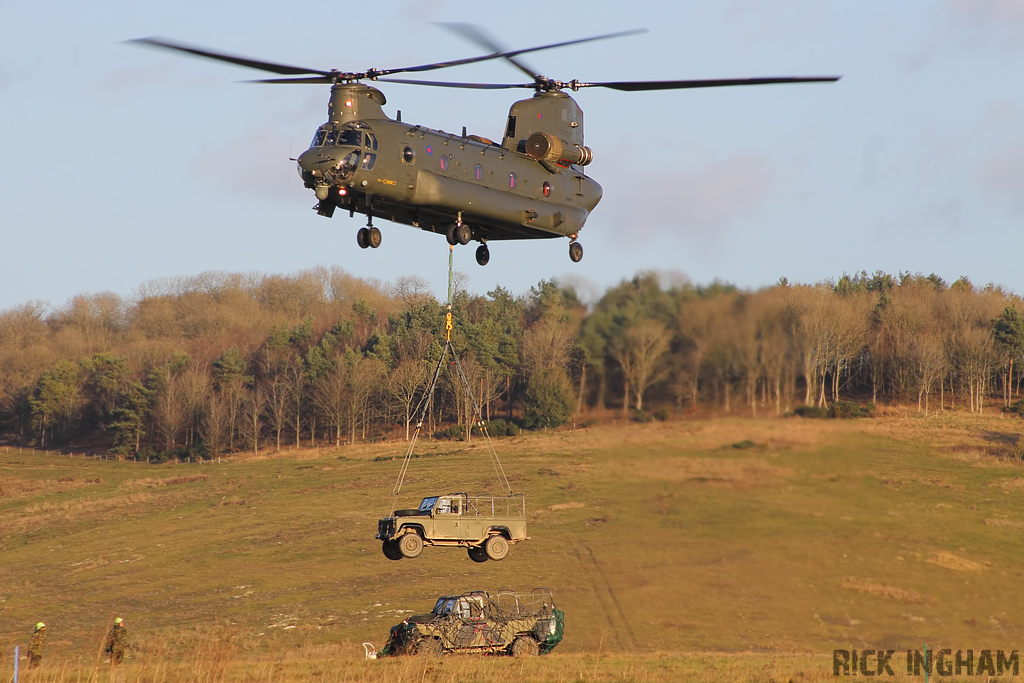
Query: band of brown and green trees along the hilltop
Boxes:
[{"xmin": 0, "ymin": 268, "xmax": 1024, "ymax": 459}]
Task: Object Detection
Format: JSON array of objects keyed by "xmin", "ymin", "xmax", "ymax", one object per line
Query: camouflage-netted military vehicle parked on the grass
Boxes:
[{"xmin": 381, "ymin": 588, "xmax": 565, "ymax": 656}]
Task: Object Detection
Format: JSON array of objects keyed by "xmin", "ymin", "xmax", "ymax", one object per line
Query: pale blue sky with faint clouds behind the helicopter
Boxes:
[{"xmin": 0, "ymin": 0, "xmax": 1024, "ymax": 311}]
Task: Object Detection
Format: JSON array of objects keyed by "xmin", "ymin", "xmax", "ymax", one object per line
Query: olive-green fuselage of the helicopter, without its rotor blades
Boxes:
[{"xmin": 298, "ymin": 83, "xmax": 601, "ymax": 242}]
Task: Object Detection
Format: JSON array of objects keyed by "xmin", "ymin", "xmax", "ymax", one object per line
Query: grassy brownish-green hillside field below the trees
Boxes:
[{"xmin": 0, "ymin": 414, "xmax": 1024, "ymax": 681}]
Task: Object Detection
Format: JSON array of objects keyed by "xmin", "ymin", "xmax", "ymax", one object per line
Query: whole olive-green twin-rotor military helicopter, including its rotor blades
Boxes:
[{"xmin": 130, "ymin": 24, "xmax": 840, "ymax": 265}]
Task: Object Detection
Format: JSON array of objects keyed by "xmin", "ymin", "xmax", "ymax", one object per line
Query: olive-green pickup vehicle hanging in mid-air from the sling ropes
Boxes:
[{"xmin": 376, "ymin": 494, "xmax": 529, "ymax": 562}]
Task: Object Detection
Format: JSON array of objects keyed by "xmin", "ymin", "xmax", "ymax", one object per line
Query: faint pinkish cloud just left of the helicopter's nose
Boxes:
[{"xmin": 193, "ymin": 127, "xmax": 302, "ymax": 202}]
